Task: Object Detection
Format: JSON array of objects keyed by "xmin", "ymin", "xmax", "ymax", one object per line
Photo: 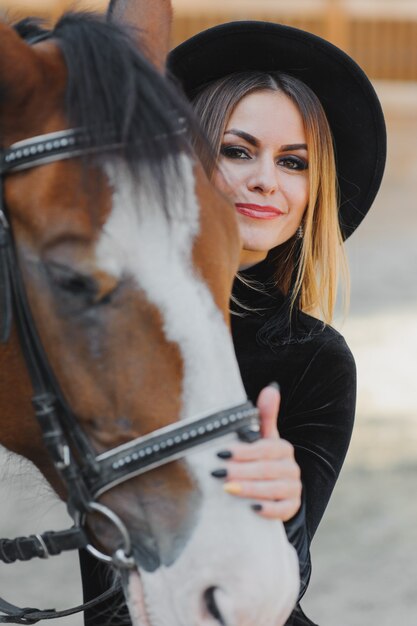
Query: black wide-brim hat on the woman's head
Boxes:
[{"xmin": 168, "ymin": 21, "xmax": 386, "ymax": 239}]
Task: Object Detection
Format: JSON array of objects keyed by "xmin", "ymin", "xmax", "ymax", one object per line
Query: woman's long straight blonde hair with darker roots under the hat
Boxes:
[{"xmin": 193, "ymin": 71, "xmax": 349, "ymax": 323}]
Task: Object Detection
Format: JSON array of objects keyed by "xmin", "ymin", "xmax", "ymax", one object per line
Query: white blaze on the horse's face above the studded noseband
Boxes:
[{"xmin": 97, "ymin": 155, "xmax": 246, "ymax": 418}]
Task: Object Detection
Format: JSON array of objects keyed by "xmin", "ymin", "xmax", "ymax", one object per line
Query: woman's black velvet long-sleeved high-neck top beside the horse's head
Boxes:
[{"xmin": 81, "ymin": 261, "xmax": 356, "ymax": 626}]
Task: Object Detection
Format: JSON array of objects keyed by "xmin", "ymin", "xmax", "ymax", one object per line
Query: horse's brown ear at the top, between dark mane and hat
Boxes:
[{"xmin": 107, "ymin": 0, "xmax": 172, "ymax": 72}]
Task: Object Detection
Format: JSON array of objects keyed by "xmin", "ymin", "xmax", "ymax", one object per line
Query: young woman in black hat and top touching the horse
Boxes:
[{"xmin": 165, "ymin": 22, "xmax": 386, "ymax": 626}]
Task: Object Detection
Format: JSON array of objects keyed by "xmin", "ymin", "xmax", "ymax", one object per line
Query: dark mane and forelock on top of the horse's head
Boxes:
[{"xmin": 14, "ymin": 12, "xmax": 211, "ymax": 210}]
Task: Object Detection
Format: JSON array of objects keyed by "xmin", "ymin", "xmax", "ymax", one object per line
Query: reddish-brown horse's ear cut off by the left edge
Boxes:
[{"xmin": 0, "ymin": 23, "xmax": 41, "ymax": 127}]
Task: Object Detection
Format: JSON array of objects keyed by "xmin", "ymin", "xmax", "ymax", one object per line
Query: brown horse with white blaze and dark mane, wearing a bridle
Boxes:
[{"xmin": 0, "ymin": 0, "xmax": 298, "ymax": 626}]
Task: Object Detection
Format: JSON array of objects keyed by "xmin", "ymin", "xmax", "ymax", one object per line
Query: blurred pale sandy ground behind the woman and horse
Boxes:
[{"xmin": 0, "ymin": 83, "xmax": 417, "ymax": 626}]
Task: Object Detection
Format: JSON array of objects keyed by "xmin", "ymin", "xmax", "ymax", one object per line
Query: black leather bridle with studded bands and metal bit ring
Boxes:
[{"xmin": 0, "ymin": 129, "xmax": 259, "ymax": 624}]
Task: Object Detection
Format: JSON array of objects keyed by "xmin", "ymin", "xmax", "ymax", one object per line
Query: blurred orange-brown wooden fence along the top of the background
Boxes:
[{"xmin": 0, "ymin": 0, "xmax": 417, "ymax": 81}]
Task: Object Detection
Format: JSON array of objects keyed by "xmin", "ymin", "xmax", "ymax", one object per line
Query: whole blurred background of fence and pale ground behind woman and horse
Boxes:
[{"xmin": 0, "ymin": 0, "xmax": 417, "ymax": 626}]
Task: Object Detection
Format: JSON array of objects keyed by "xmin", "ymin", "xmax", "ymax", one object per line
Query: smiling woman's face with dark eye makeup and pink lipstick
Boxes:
[{"xmin": 213, "ymin": 90, "xmax": 309, "ymax": 268}]
